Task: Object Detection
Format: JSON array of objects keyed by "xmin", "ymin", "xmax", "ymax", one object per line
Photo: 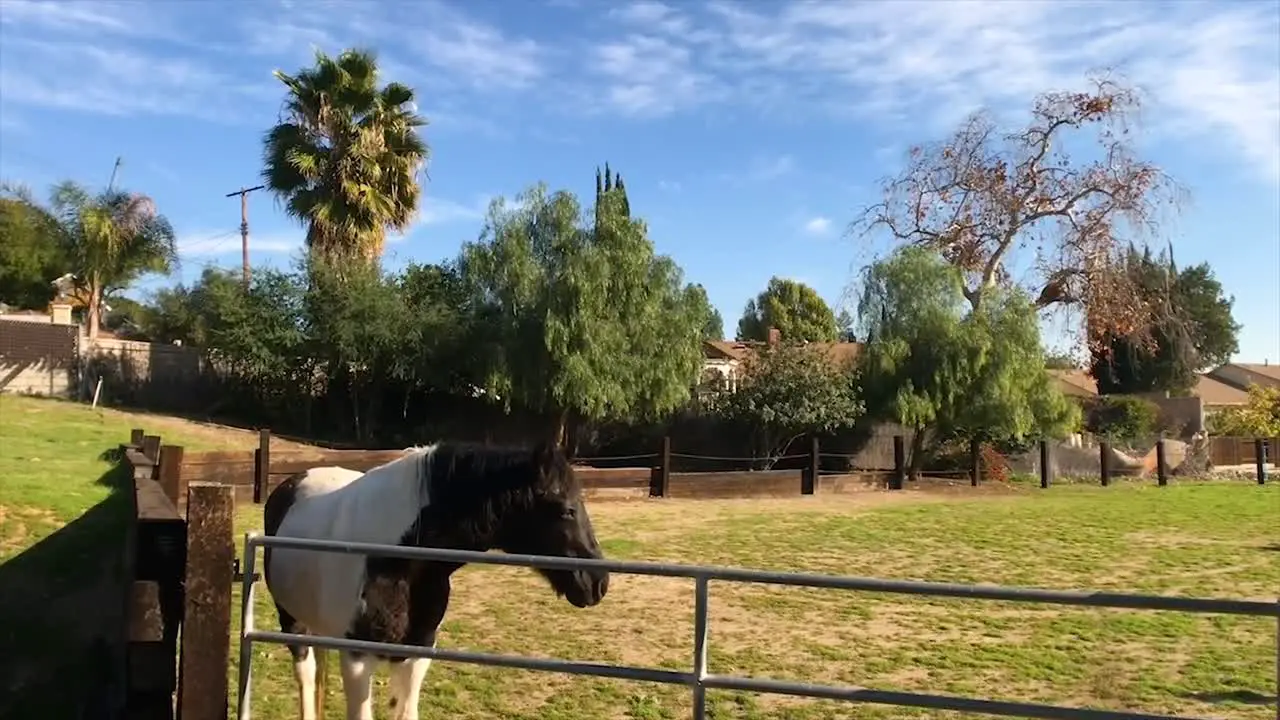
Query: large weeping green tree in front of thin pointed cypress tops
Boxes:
[{"xmin": 460, "ymin": 184, "xmax": 707, "ymax": 442}]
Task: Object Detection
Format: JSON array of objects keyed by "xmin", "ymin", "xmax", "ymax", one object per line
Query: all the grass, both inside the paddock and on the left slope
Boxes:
[{"xmin": 0, "ymin": 396, "xmax": 1280, "ymax": 720}]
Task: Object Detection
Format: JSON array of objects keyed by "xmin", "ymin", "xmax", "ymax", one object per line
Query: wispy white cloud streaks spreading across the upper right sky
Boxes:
[{"xmin": 611, "ymin": 0, "xmax": 1280, "ymax": 181}]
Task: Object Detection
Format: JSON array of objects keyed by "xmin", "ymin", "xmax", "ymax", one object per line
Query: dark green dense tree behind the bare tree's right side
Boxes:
[{"xmin": 1089, "ymin": 247, "xmax": 1240, "ymax": 395}]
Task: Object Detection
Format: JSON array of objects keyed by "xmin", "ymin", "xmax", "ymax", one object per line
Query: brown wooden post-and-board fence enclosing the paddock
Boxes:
[{"xmin": 120, "ymin": 429, "xmax": 1267, "ymax": 720}]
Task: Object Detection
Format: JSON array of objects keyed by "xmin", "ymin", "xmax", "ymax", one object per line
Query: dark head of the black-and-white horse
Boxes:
[{"xmin": 497, "ymin": 445, "xmax": 609, "ymax": 607}]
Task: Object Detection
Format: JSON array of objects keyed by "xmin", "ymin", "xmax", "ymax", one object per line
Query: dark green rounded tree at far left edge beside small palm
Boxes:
[{"xmin": 0, "ymin": 184, "xmax": 70, "ymax": 310}]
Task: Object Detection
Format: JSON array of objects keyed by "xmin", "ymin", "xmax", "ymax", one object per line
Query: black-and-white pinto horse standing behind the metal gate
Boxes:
[{"xmin": 262, "ymin": 442, "xmax": 609, "ymax": 720}]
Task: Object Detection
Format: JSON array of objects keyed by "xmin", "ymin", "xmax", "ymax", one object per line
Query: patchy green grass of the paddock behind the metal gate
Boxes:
[{"xmin": 232, "ymin": 482, "xmax": 1280, "ymax": 720}]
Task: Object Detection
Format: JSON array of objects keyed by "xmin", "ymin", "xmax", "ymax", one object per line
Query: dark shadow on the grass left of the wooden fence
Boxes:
[{"xmin": 0, "ymin": 465, "xmax": 132, "ymax": 720}]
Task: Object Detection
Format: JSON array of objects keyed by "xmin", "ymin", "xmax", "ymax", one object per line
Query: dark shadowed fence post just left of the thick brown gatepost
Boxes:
[{"xmin": 124, "ymin": 580, "xmax": 174, "ymax": 720}]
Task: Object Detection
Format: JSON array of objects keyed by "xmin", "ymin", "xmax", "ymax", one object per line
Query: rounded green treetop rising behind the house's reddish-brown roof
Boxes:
[{"xmin": 737, "ymin": 277, "xmax": 840, "ymax": 342}]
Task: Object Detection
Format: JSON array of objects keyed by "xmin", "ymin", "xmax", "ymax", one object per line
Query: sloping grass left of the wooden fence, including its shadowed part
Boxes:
[{"xmin": 0, "ymin": 395, "xmax": 282, "ymax": 717}]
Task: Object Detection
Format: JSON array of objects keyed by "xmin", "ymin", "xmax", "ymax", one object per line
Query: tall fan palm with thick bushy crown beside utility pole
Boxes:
[{"xmin": 262, "ymin": 50, "xmax": 429, "ymax": 260}]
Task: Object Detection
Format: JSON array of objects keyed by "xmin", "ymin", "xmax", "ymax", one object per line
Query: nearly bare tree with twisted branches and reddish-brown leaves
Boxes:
[{"xmin": 850, "ymin": 77, "xmax": 1183, "ymax": 345}]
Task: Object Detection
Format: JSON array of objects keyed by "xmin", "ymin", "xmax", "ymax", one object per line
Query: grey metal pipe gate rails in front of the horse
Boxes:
[{"xmin": 238, "ymin": 533, "xmax": 1280, "ymax": 720}]
